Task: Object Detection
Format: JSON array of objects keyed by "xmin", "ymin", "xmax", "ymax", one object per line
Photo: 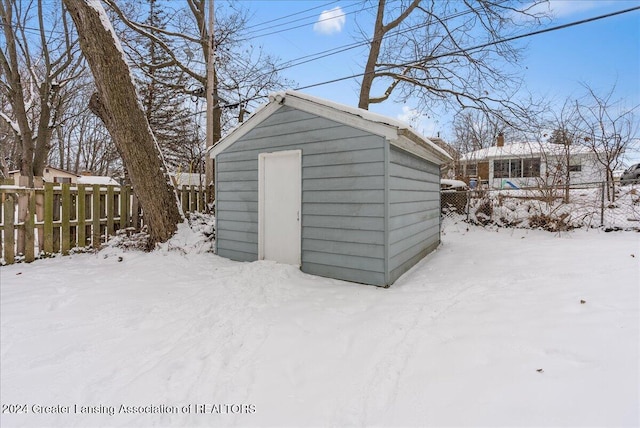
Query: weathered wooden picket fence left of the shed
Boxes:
[{"xmin": 0, "ymin": 183, "xmax": 210, "ymax": 264}]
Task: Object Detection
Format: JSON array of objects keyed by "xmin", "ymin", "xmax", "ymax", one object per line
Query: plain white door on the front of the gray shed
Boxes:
[{"xmin": 258, "ymin": 150, "xmax": 302, "ymax": 265}]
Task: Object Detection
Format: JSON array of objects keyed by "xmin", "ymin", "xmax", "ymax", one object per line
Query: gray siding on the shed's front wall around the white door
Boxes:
[{"xmin": 216, "ymin": 106, "xmax": 385, "ymax": 285}]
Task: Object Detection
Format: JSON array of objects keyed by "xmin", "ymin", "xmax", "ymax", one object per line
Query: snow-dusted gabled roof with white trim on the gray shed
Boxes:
[{"xmin": 209, "ymin": 91, "xmax": 451, "ymax": 164}]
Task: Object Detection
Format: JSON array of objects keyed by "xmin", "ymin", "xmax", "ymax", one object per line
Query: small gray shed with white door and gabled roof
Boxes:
[{"xmin": 209, "ymin": 91, "xmax": 450, "ymax": 286}]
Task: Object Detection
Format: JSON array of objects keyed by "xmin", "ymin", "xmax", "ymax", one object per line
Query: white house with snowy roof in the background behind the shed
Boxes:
[{"xmin": 460, "ymin": 139, "xmax": 606, "ymax": 189}]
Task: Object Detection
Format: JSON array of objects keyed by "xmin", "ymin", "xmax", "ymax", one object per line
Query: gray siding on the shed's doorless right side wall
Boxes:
[{"xmin": 388, "ymin": 146, "xmax": 440, "ymax": 283}]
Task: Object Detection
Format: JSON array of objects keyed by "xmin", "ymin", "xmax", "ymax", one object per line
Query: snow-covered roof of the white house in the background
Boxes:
[{"xmin": 460, "ymin": 142, "xmax": 591, "ymax": 161}]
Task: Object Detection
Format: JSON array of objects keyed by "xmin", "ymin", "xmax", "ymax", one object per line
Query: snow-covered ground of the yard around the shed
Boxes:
[{"xmin": 0, "ymin": 219, "xmax": 640, "ymax": 427}]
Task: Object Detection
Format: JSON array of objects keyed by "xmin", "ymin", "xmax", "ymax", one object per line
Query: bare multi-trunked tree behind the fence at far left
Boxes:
[{"xmin": 0, "ymin": 0, "xmax": 82, "ymax": 187}]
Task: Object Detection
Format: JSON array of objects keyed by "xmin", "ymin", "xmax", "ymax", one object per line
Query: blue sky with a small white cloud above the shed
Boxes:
[{"xmin": 231, "ymin": 0, "xmax": 640, "ymax": 156}]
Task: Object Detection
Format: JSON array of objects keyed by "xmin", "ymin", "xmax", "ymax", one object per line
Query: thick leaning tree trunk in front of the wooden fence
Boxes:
[{"xmin": 63, "ymin": 0, "xmax": 181, "ymax": 248}]
